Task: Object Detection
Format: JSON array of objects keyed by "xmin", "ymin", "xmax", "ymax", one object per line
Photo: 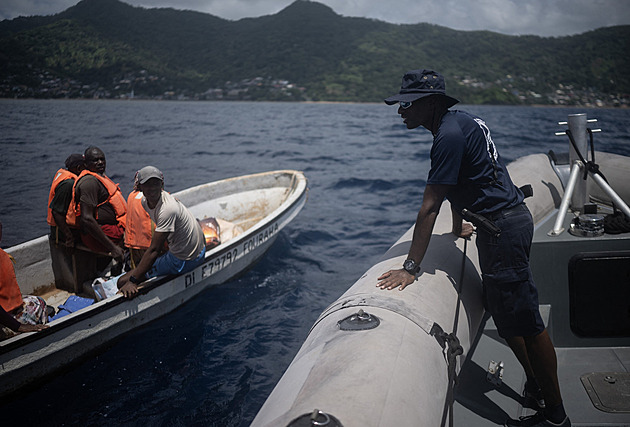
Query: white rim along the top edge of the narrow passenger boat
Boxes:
[{"xmin": 0, "ymin": 170, "xmax": 308, "ymax": 354}]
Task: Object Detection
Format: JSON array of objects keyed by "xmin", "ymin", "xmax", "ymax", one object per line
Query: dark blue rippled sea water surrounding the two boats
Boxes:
[{"xmin": 0, "ymin": 100, "xmax": 630, "ymax": 427}]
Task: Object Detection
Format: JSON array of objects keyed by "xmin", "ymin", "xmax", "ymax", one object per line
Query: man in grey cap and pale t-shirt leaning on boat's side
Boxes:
[{"xmin": 117, "ymin": 166, "xmax": 206, "ymax": 297}]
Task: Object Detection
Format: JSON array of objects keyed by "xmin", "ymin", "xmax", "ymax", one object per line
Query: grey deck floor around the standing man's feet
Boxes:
[{"xmin": 453, "ymin": 306, "xmax": 630, "ymax": 427}]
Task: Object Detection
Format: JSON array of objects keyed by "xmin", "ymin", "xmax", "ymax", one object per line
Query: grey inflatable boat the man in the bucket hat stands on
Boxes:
[{"xmin": 252, "ymin": 115, "xmax": 630, "ymax": 427}]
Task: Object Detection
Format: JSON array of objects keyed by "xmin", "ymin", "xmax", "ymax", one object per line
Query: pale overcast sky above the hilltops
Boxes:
[{"xmin": 0, "ymin": 0, "xmax": 630, "ymax": 37}]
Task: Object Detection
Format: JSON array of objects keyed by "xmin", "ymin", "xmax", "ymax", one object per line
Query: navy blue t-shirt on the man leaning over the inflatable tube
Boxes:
[{"xmin": 427, "ymin": 110, "xmax": 524, "ymax": 214}]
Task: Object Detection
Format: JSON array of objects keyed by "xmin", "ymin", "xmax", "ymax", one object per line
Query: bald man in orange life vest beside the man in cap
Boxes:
[{"xmin": 66, "ymin": 147, "xmax": 127, "ymax": 261}]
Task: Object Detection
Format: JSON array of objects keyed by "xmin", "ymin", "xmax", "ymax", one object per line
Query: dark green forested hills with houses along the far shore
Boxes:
[{"xmin": 0, "ymin": 0, "xmax": 630, "ymax": 105}]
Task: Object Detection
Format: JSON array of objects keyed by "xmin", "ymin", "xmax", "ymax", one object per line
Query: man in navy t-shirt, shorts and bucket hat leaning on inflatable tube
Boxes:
[{"xmin": 377, "ymin": 70, "xmax": 571, "ymax": 427}]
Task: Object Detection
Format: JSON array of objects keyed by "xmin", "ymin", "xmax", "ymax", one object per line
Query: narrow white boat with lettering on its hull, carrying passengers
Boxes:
[{"xmin": 0, "ymin": 170, "xmax": 307, "ymax": 395}]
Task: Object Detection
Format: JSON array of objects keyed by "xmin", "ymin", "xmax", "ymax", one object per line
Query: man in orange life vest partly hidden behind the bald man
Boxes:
[{"xmin": 46, "ymin": 154, "xmax": 85, "ymax": 247}]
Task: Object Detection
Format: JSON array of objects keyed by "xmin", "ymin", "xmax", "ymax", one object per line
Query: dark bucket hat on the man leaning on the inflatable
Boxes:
[{"xmin": 385, "ymin": 70, "xmax": 459, "ymax": 108}]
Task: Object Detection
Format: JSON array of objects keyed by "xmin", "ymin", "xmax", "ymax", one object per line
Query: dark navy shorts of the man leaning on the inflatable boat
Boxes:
[{"xmin": 477, "ymin": 203, "xmax": 545, "ymax": 338}]
